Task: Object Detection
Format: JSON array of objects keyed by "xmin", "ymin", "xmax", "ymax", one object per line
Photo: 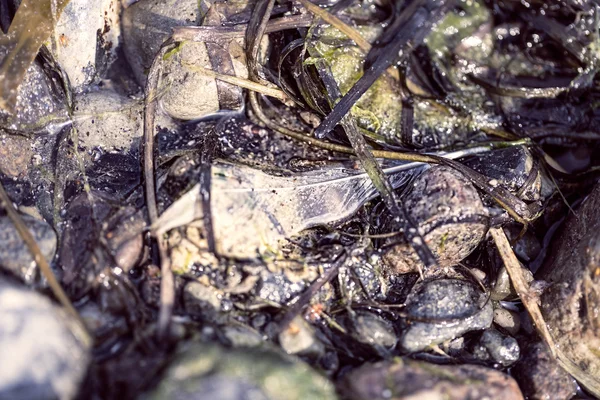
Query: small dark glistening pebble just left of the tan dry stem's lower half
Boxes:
[{"xmin": 473, "ymin": 329, "xmax": 520, "ymax": 367}]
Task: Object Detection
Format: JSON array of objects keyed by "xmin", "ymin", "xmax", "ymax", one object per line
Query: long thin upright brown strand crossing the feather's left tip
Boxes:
[{"xmin": 143, "ymin": 40, "xmax": 175, "ymax": 339}]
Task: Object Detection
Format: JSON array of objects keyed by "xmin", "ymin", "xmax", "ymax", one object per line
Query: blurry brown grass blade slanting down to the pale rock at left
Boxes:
[{"xmin": 0, "ymin": 183, "xmax": 90, "ymax": 341}]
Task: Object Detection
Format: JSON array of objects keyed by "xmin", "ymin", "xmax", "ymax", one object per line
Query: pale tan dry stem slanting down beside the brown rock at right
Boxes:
[{"xmin": 490, "ymin": 228, "xmax": 556, "ymax": 357}]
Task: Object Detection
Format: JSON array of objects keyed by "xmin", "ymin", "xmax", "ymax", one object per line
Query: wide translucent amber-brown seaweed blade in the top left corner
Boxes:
[{"xmin": 0, "ymin": 0, "xmax": 69, "ymax": 112}]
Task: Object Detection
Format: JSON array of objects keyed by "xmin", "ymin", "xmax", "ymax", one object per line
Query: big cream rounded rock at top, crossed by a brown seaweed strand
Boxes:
[{"xmin": 123, "ymin": 0, "xmax": 247, "ymax": 120}]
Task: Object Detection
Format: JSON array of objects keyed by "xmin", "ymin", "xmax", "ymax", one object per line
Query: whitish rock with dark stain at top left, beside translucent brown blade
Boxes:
[{"xmin": 53, "ymin": 0, "xmax": 121, "ymax": 91}]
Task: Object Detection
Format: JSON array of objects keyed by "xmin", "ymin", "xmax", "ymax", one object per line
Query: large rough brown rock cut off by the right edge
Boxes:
[{"xmin": 540, "ymin": 186, "xmax": 600, "ymax": 396}]
